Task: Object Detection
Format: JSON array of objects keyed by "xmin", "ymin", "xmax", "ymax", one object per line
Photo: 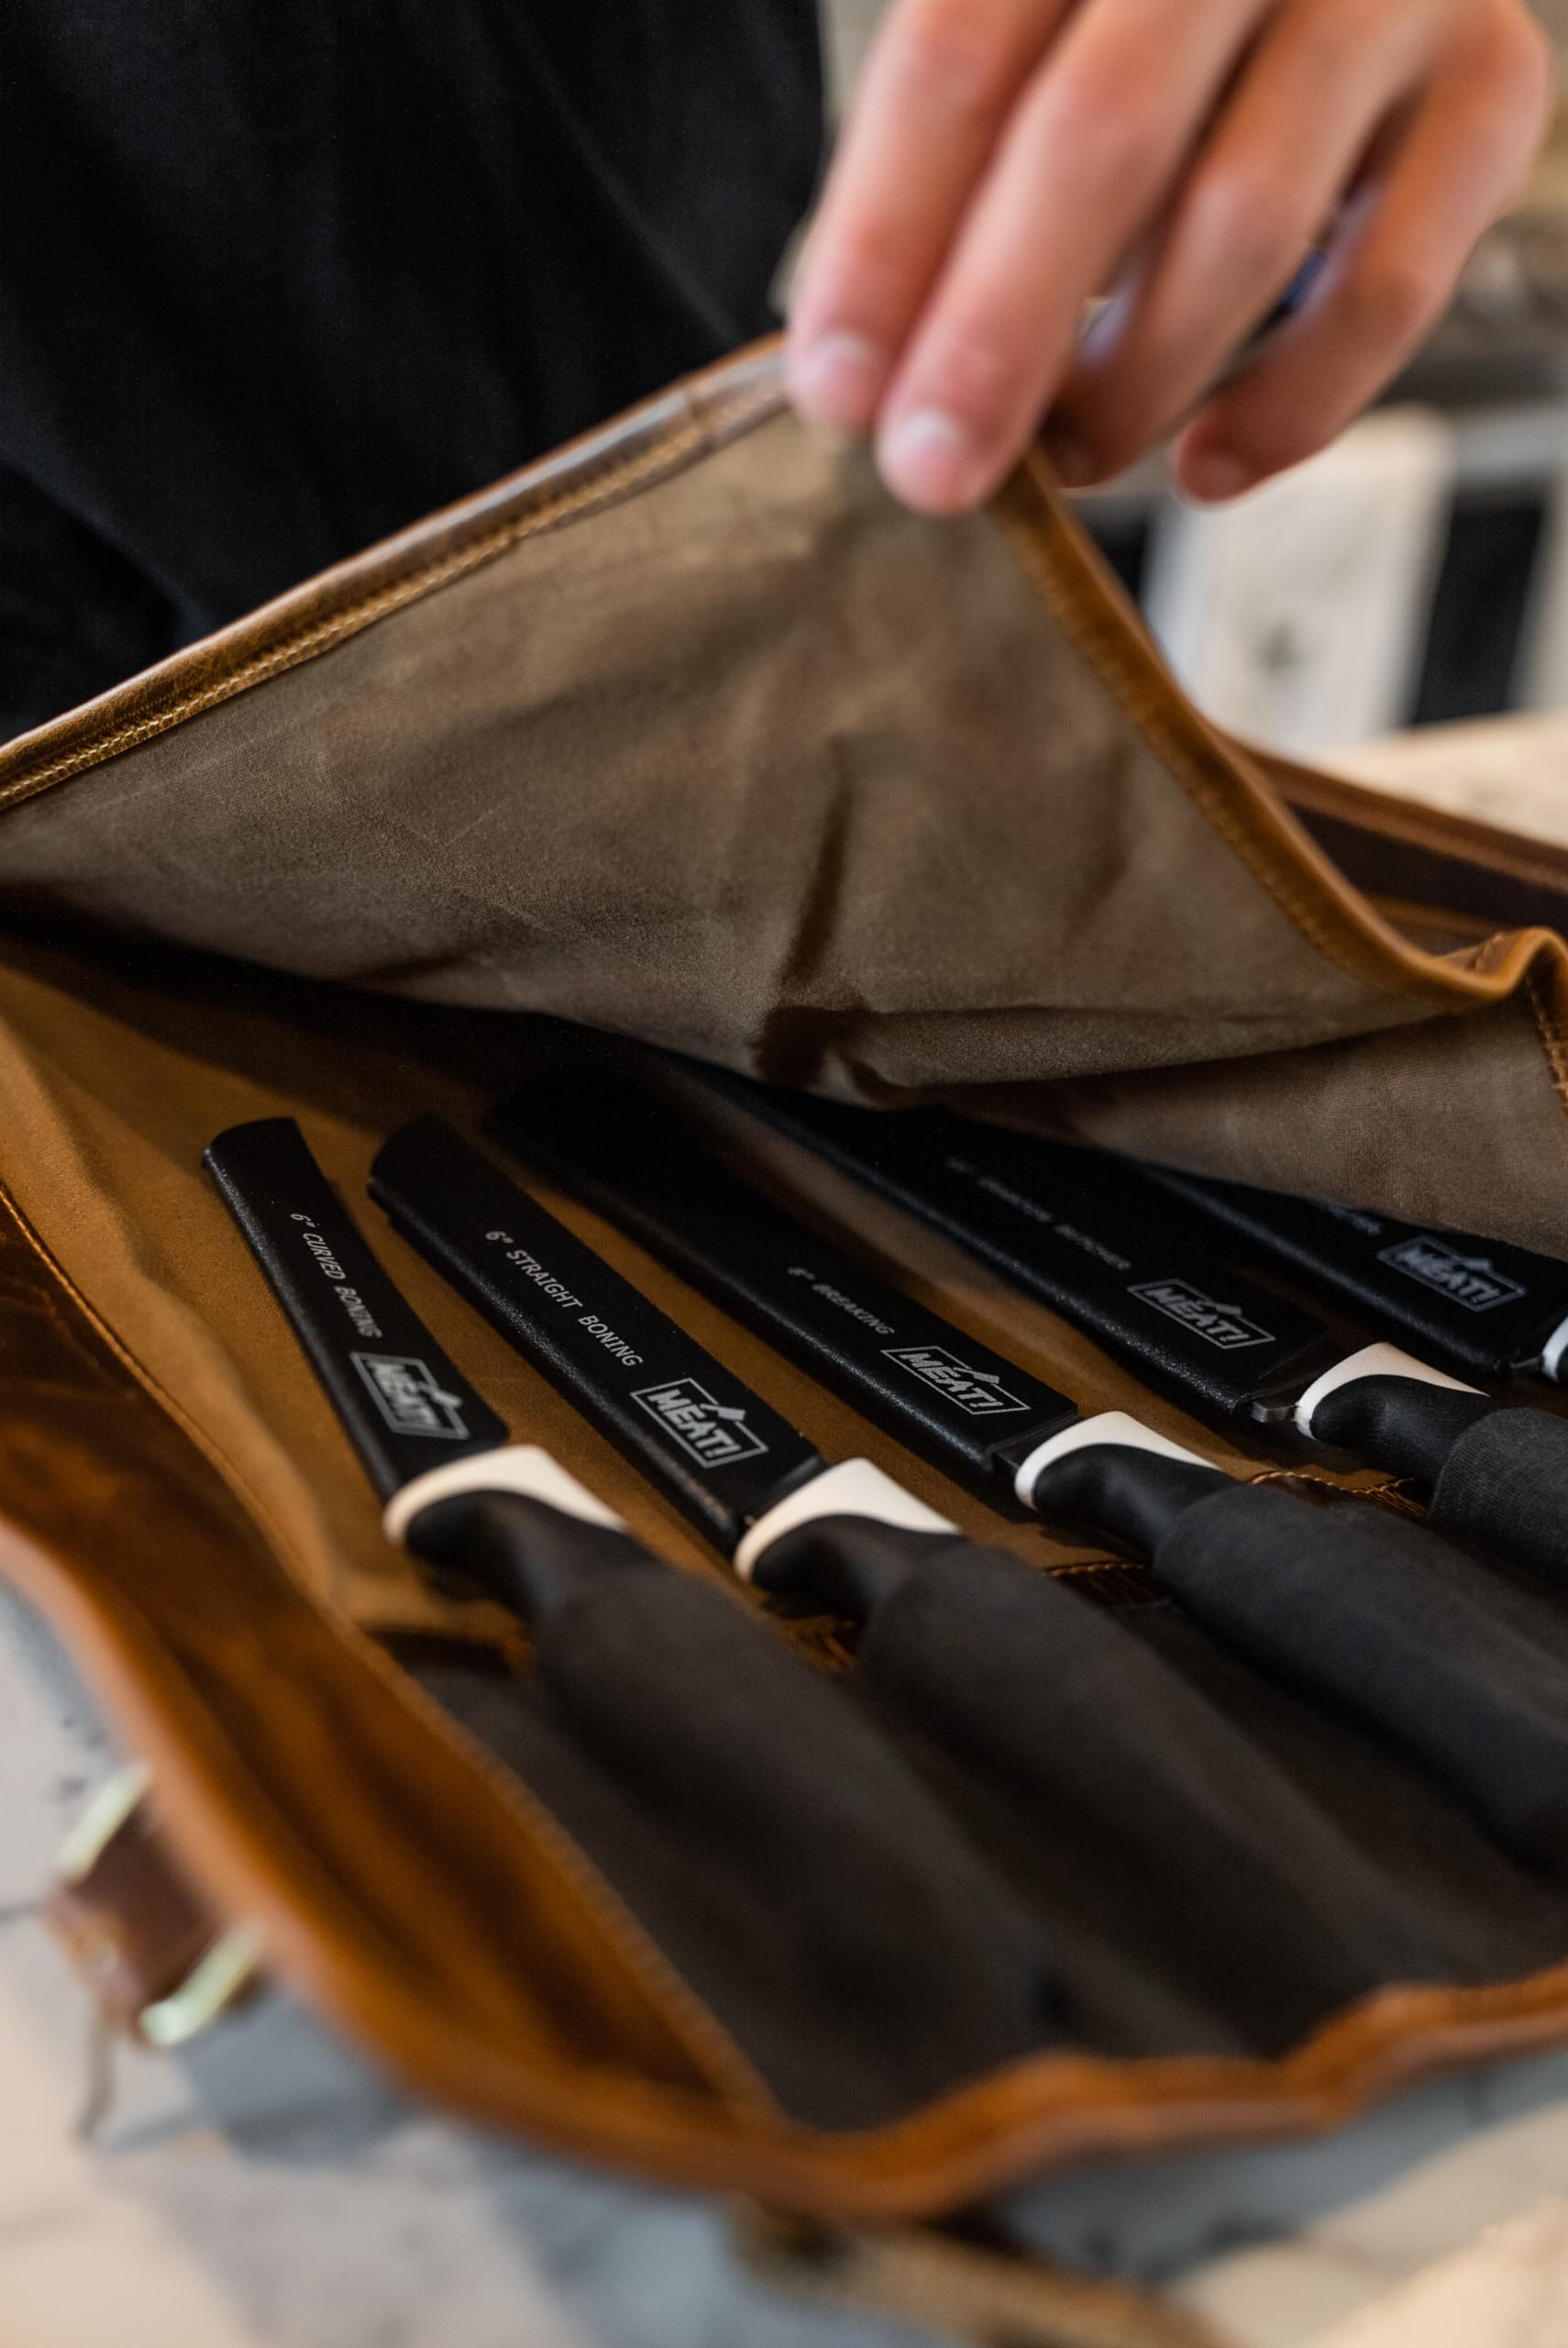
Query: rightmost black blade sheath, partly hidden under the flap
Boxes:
[{"xmin": 1141, "ymin": 1160, "xmax": 1568, "ymax": 1385}]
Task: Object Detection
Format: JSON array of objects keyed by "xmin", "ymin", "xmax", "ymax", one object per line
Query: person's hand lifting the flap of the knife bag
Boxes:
[{"xmin": 789, "ymin": 0, "xmax": 1551, "ymax": 515}]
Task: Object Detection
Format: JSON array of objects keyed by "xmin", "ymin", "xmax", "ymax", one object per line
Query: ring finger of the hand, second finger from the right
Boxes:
[{"xmin": 1047, "ymin": 0, "xmax": 1425, "ymax": 483}]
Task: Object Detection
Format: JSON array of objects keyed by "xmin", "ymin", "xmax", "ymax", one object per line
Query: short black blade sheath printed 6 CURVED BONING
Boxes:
[{"xmin": 204, "ymin": 1118, "xmax": 507, "ymax": 1501}]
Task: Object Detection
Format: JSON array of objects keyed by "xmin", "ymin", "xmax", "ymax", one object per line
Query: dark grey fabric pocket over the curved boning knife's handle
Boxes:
[{"xmin": 389, "ymin": 1498, "xmax": 1061, "ymax": 2127}]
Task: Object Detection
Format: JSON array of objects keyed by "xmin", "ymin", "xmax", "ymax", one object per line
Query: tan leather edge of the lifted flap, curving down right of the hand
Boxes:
[{"xmin": 990, "ymin": 451, "xmax": 1568, "ymax": 1012}]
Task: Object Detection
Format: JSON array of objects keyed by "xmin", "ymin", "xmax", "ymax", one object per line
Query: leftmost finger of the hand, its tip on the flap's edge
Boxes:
[{"xmin": 789, "ymin": 0, "xmax": 1073, "ymax": 432}]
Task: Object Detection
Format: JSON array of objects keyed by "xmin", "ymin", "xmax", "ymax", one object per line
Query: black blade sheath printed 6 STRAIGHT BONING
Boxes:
[{"xmin": 370, "ymin": 1118, "xmax": 824, "ymax": 1556}]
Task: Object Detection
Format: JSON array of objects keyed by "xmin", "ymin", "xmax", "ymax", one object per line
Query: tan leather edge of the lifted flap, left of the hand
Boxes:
[{"xmin": 0, "ymin": 336, "xmax": 784, "ymax": 808}]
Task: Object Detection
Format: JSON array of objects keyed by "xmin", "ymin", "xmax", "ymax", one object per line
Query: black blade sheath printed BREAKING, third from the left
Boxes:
[{"xmin": 491, "ymin": 1075, "xmax": 1077, "ymax": 1514}]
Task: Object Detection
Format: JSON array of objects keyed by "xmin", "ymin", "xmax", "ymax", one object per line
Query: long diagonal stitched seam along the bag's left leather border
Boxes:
[{"xmin": 0, "ymin": 1186, "xmax": 779, "ymax": 2116}]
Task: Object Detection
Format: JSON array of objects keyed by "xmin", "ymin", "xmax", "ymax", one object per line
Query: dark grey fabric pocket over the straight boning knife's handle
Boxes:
[{"xmin": 779, "ymin": 1519, "xmax": 1502, "ymax": 2052}]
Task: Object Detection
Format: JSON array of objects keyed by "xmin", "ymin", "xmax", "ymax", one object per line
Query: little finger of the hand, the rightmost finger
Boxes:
[{"xmin": 1178, "ymin": 7, "xmax": 1550, "ymax": 498}]
